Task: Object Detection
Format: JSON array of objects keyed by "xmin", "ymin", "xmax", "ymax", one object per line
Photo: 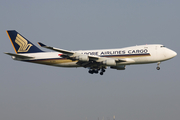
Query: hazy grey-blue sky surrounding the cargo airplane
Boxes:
[{"xmin": 0, "ymin": 0, "xmax": 180, "ymax": 120}]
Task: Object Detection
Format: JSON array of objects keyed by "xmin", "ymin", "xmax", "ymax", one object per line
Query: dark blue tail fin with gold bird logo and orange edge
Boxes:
[{"xmin": 6, "ymin": 30, "xmax": 43, "ymax": 53}]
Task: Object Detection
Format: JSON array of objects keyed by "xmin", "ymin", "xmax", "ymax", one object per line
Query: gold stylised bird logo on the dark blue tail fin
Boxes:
[{"xmin": 15, "ymin": 34, "xmax": 32, "ymax": 52}]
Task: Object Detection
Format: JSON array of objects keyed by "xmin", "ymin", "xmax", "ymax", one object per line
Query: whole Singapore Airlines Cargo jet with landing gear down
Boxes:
[{"xmin": 5, "ymin": 30, "xmax": 177, "ymax": 75}]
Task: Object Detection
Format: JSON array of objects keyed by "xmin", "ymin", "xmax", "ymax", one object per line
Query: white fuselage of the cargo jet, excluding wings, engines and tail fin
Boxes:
[{"xmin": 13, "ymin": 44, "xmax": 177, "ymax": 67}]
